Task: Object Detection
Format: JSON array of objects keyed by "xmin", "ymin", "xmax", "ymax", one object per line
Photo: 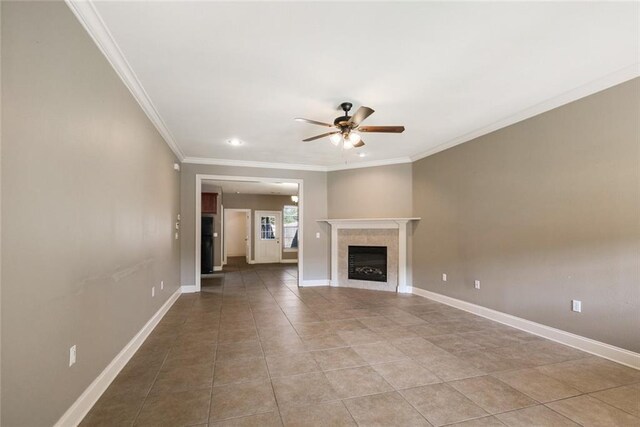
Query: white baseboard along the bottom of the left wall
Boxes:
[{"xmin": 54, "ymin": 288, "xmax": 182, "ymax": 427}]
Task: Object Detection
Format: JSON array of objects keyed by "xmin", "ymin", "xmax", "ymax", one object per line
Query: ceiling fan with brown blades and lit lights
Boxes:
[{"xmin": 294, "ymin": 102, "xmax": 404, "ymax": 149}]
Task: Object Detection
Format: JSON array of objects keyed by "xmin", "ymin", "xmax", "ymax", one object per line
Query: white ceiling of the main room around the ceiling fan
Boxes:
[{"xmin": 79, "ymin": 0, "xmax": 640, "ymax": 168}]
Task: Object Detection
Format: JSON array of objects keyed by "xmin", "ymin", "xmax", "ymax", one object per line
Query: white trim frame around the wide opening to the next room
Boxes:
[{"xmin": 192, "ymin": 174, "xmax": 304, "ymax": 293}]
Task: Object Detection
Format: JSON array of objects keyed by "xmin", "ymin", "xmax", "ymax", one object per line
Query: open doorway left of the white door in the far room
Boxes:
[{"xmin": 223, "ymin": 208, "xmax": 251, "ymax": 264}]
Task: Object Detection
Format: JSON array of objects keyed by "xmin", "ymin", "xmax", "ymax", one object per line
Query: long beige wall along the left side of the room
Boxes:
[{"xmin": 0, "ymin": 2, "xmax": 180, "ymax": 426}]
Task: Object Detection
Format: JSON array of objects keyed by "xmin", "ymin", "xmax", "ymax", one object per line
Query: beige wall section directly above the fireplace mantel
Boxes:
[{"xmin": 327, "ymin": 163, "xmax": 413, "ymax": 218}]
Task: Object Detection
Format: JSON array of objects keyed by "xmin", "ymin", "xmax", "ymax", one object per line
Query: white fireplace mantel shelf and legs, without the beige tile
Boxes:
[{"xmin": 318, "ymin": 218, "xmax": 420, "ymax": 293}]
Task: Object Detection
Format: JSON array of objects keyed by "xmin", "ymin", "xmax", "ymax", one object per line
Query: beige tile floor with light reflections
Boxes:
[{"xmin": 82, "ymin": 260, "xmax": 640, "ymax": 426}]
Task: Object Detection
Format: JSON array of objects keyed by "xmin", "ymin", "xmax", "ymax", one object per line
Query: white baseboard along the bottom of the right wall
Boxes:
[{"xmin": 413, "ymin": 287, "xmax": 640, "ymax": 369}]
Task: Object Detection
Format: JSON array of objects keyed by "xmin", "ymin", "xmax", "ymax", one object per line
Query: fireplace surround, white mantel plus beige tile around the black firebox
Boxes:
[{"xmin": 322, "ymin": 218, "xmax": 420, "ymax": 293}]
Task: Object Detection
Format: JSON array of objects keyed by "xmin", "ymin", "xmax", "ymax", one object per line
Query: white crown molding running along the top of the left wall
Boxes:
[{"xmin": 65, "ymin": 0, "xmax": 184, "ymax": 161}]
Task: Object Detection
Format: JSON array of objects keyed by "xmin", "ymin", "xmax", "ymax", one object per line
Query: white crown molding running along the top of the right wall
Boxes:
[{"xmin": 411, "ymin": 63, "xmax": 640, "ymax": 162}]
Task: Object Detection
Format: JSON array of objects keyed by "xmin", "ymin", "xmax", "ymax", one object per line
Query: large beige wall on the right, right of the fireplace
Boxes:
[{"xmin": 413, "ymin": 79, "xmax": 640, "ymax": 352}]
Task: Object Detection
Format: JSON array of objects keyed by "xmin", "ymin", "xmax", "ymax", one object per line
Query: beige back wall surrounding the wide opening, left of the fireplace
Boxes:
[{"xmin": 180, "ymin": 163, "xmax": 331, "ymax": 285}]
